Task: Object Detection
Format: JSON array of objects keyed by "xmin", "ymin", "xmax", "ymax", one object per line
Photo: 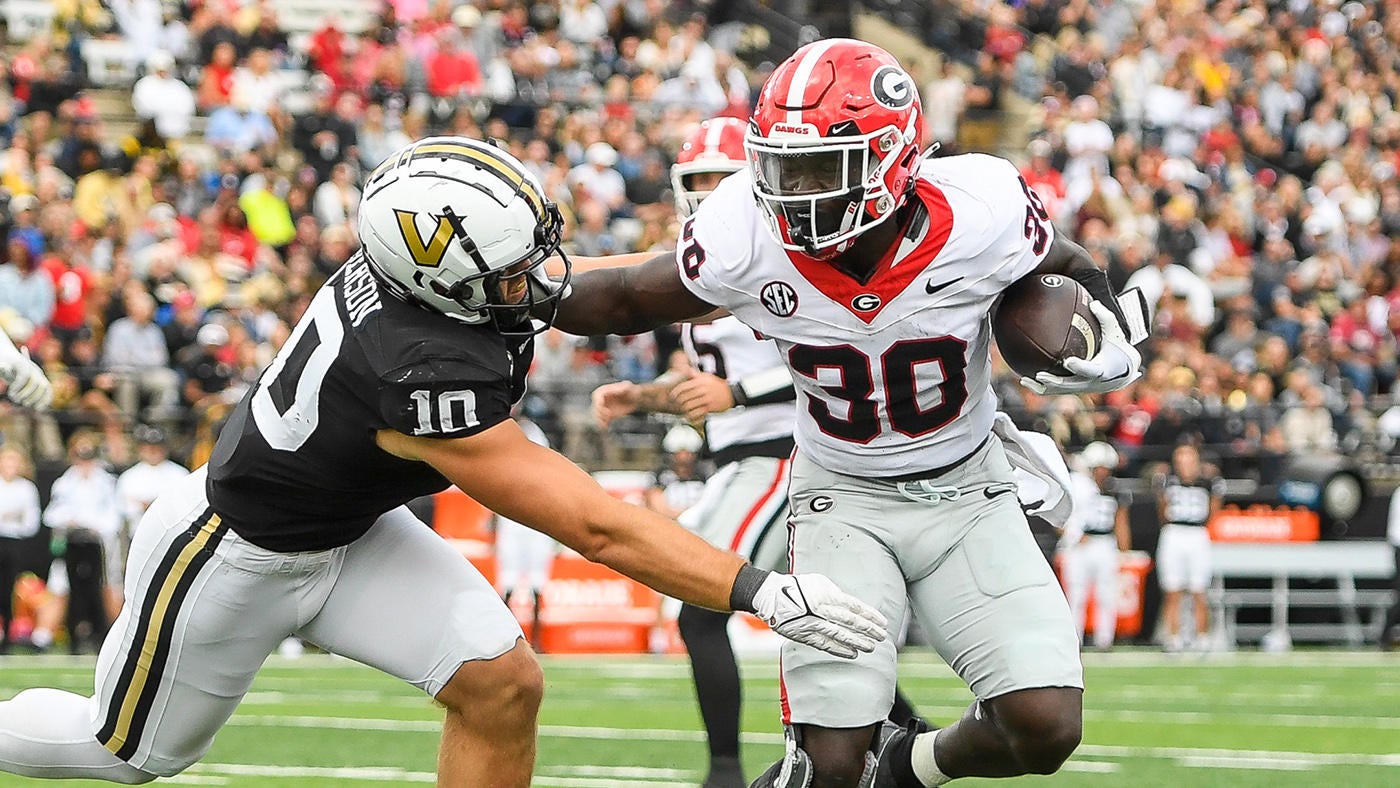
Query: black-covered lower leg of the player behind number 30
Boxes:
[{"xmin": 676, "ymin": 605, "xmax": 741, "ymax": 759}]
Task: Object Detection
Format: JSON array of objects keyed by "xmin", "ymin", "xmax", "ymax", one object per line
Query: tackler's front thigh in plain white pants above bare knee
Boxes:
[{"xmin": 298, "ymin": 507, "xmax": 522, "ymax": 696}]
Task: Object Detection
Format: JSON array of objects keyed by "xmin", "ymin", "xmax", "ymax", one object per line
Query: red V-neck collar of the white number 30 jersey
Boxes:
[{"xmin": 788, "ymin": 178, "xmax": 953, "ymax": 323}]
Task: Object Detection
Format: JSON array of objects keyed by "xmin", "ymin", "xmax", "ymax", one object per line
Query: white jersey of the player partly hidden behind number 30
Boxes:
[{"xmin": 680, "ymin": 316, "xmax": 795, "ymax": 451}]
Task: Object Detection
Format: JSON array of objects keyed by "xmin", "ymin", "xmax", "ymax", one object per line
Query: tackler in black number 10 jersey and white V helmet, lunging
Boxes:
[{"xmin": 0, "ymin": 137, "xmax": 883, "ymax": 788}]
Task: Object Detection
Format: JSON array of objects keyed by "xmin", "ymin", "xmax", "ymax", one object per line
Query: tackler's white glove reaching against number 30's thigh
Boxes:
[{"xmin": 753, "ymin": 572, "xmax": 888, "ymax": 659}]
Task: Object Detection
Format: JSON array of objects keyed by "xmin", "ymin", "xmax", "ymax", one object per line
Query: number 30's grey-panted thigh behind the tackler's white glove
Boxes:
[{"xmin": 783, "ymin": 459, "xmax": 907, "ymax": 728}]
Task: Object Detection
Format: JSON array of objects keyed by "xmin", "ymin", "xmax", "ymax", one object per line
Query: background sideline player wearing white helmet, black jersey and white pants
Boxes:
[{"xmin": 1064, "ymin": 441, "xmax": 1133, "ymax": 651}]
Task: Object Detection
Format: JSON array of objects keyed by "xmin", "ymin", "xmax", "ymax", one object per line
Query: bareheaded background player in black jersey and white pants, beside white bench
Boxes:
[{"xmin": 1156, "ymin": 444, "xmax": 1222, "ymax": 651}]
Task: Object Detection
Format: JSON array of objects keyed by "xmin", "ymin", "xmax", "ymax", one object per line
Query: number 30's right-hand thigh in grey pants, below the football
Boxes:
[{"xmin": 910, "ymin": 490, "xmax": 1084, "ymax": 698}]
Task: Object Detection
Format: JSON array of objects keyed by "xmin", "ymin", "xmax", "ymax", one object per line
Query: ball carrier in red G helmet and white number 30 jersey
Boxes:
[{"xmin": 534, "ymin": 39, "xmax": 1147, "ymax": 788}]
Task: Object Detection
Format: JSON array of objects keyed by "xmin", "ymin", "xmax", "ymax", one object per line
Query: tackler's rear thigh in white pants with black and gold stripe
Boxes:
[{"xmin": 92, "ymin": 473, "xmax": 297, "ymax": 775}]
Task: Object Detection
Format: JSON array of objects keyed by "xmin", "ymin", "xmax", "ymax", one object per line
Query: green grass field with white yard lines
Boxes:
[{"xmin": 0, "ymin": 651, "xmax": 1400, "ymax": 788}]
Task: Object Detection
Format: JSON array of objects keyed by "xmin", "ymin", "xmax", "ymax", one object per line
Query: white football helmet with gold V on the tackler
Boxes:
[{"xmin": 360, "ymin": 137, "xmax": 568, "ymax": 335}]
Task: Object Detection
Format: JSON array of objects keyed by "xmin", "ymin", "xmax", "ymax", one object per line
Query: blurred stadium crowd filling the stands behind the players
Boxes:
[{"xmin": 0, "ymin": 0, "xmax": 1400, "ymax": 649}]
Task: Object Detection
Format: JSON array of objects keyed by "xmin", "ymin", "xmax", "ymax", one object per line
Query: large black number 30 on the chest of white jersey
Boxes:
[{"xmin": 788, "ymin": 336, "xmax": 967, "ymax": 444}]
